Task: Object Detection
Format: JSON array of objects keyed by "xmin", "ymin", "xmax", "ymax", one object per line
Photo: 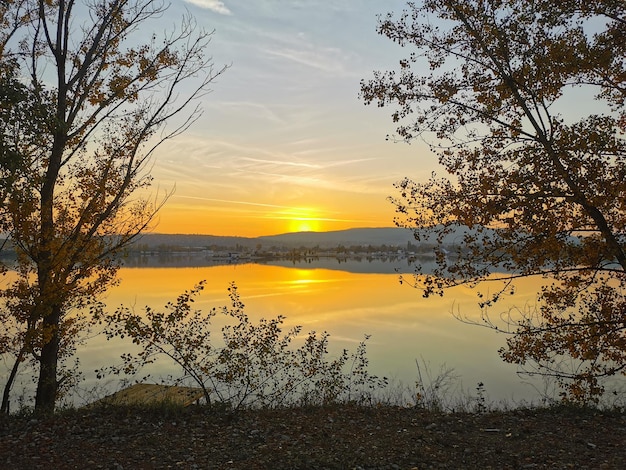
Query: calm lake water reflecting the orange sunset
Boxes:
[{"xmin": 73, "ymin": 260, "xmax": 539, "ymax": 402}]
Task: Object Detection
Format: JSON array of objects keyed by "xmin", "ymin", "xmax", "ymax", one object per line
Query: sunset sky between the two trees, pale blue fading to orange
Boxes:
[{"xmin": 152, "ymin": 0, "xmax": 436, "ymax": 237}]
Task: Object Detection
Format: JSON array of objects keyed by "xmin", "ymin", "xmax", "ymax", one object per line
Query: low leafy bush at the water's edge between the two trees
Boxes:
[{"xmin": 98, "ymin": 281, "xmax": 387, "ymax": 409}]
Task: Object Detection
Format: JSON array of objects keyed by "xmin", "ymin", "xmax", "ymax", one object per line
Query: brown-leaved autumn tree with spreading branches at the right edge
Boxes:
[{"xmin": 361, "ymin": 0, "xmax": 626, "ymax": 401}]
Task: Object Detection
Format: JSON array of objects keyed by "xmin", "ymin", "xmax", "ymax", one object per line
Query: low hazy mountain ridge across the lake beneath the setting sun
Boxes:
[{"xmin": 135, "ymin": 227, "xmax": 415, "ymax": 249}]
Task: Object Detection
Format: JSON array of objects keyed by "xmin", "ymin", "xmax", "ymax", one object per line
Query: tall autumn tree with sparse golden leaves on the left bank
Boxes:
[{"xmin": 2, "ymin": 0, "xmax": 224, "ymax": 412}]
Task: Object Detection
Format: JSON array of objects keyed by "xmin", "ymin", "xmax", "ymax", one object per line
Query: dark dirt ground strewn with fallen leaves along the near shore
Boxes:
[{"xmin": 0, "ymin": 405, "xmax": 626, "ymax": 470}]
